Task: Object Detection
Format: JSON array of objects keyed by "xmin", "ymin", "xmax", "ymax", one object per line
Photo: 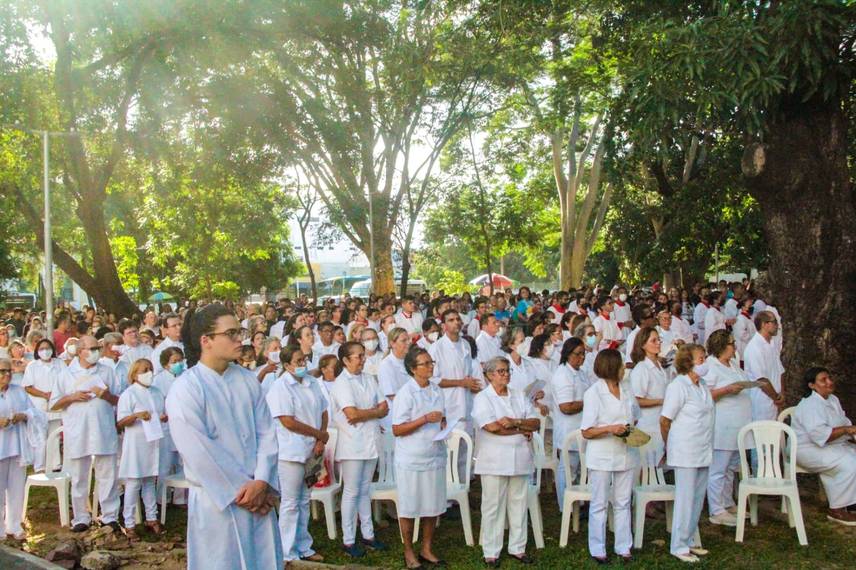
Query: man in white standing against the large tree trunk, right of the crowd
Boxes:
[{"xmin": 743, "ymin": 311, "xmax": 785, "ymax": 422}]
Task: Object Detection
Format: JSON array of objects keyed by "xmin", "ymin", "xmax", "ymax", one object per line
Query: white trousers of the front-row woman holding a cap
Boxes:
[{"xmin": 588, "ymin": 469, "xmax": 636, "ymax": 557}]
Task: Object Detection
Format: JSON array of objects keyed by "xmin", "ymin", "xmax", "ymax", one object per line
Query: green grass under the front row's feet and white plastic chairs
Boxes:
[{"xmin": 20, "ymin": 477, "xmax": 856, "ymax": 570}]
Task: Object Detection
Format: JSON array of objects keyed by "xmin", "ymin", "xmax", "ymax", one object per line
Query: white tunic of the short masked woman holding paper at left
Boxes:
[{"xmin": 116, "ymin": 382, "xmax": 168, "ymax": 479}]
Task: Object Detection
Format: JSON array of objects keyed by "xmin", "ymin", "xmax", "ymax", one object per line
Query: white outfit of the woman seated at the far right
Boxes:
[{"xmin": 791, "ymin": 392, "xmax": 856, "ymax": 509}]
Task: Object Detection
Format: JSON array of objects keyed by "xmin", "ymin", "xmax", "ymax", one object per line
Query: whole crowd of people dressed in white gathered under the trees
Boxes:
[{"xmin": 0, "ymin": 282, "xmax": 856, "ymax": 568}]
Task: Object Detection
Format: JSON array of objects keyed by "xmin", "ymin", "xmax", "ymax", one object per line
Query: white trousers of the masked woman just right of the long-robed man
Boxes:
[{"xmin": 279, "ymin": 461, "xmax": 315, "ymax": 562}]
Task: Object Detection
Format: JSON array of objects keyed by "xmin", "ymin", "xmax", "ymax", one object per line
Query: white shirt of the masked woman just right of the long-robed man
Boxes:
[{"xmin": 266, "ymin": 372, "xmax": 327, "ymax": 463}]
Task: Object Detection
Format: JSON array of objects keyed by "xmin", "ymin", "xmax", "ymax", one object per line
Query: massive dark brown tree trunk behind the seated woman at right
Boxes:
[{"xmin": 743, "ymin": 96, "xmax": 856, "ymax": 418}]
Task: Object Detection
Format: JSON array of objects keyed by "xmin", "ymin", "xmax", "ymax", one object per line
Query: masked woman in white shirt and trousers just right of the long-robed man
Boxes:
[{"xmin": 266, "ymin": 345, "xmax": 330, "ymax": 563}]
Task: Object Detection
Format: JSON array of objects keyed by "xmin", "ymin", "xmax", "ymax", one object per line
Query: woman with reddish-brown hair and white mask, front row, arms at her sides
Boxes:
[{"xmin": 660, "ymin": 344, "xmax": 714, "ymax": 562}]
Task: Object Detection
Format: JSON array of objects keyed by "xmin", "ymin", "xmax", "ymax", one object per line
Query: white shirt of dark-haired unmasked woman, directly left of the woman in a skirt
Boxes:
[{"xmin": 330, "ymin": 370, "xmax": 384, "ymax": 461}]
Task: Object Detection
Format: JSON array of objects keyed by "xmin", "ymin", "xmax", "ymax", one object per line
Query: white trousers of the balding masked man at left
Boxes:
[{"xmin": 67, "ymin": 455, "xmax": 119, "ymax": 526}]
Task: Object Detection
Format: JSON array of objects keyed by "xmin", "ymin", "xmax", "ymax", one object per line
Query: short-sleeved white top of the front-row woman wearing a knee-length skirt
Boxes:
[{"xmin": 392, "ymin": 378, "xmax": 446, "ymax": 471}]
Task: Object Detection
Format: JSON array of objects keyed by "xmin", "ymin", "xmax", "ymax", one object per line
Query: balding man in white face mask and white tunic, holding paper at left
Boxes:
[{"xmin": 49, "ymin": 335, "xmax": 121, "ymax": 532}]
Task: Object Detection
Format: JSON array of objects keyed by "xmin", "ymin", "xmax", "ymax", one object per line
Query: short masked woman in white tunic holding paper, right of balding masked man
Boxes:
[{"xmin": 116, "ymin": 358, "xmax": 169, "ymax": 540}]
